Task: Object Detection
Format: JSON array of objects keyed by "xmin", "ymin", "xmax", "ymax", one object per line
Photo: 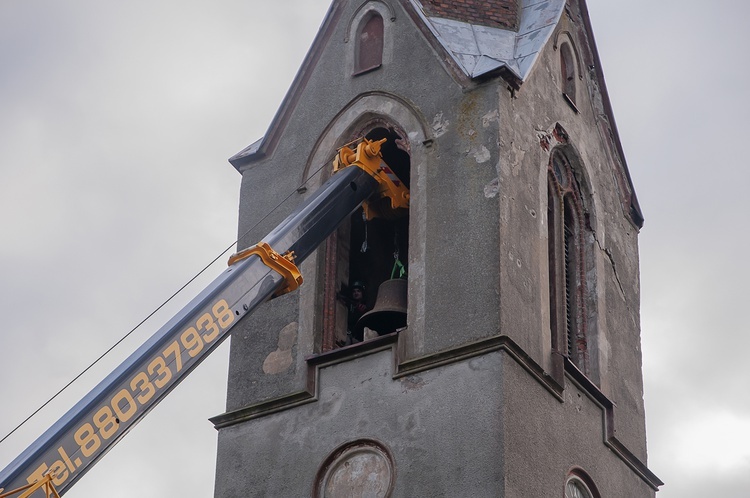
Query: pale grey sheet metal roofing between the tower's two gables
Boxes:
[{"xmin": 411, "ymin": 0, "xmax": 565, "ymax": 82}]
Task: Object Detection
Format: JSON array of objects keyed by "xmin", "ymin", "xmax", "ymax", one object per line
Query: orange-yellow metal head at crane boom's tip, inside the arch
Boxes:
[{"xmin": 333, "ymin": 138, "xmax": 409, "ymax": 220}]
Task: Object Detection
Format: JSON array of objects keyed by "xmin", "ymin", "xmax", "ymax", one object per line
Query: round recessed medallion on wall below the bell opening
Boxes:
[{"xmin": 314, "ymin": 439, "xmax": 396, "ymax": 498}]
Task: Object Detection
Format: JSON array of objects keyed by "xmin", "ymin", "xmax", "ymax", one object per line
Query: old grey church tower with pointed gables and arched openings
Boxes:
[{"xmin": 212, "ymin": 0, "xmax": 661, "ymax": 498}]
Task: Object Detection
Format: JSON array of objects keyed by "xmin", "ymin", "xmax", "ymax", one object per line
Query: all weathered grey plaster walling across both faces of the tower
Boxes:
[{"xmin": 216, "ymin": 0, "xmax": 649, "ymax": 496}]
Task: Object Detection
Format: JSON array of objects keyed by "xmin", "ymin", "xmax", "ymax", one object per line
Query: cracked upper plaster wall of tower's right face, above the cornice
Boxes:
[{"xmin": 499, "ymin": 11, "xmax": 646, "ymax": 462}]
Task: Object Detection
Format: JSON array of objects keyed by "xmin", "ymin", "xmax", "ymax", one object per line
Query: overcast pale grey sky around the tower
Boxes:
[{"xmin": 0, "ymin": 0, "xmax": 750, "ymax": 498}]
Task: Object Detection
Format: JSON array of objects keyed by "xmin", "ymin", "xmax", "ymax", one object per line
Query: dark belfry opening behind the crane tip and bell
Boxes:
[{"xmin": 323, "ymin": 127, "xmax": 410, "ymax": 352}]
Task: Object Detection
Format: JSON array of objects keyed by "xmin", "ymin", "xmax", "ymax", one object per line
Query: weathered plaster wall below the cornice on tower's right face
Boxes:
[{"xmin": 501, "ymin": 357, "xmax": 654, "ymax": 498}]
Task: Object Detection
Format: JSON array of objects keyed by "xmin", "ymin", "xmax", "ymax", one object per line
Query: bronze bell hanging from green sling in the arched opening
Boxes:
[{"xmin": 354, "ymin": 278, "xmax": 407, "ymax": 341}]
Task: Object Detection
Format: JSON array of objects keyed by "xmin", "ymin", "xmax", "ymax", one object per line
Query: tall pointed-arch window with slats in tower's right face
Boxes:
[{"xmin": 547, "ymin": 150, "xmax": 588, "ymax": 373}]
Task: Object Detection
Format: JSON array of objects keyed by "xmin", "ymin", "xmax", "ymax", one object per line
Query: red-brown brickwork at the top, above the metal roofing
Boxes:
[{"xmin": 422, "ymin": 0, "xmax": 520, "ymax": 30}]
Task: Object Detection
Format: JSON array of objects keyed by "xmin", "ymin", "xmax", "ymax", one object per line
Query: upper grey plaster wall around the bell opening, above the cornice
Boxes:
[{"xmin": 227, "ymin": 0, "xmax": 508, "ymax": 410}]
